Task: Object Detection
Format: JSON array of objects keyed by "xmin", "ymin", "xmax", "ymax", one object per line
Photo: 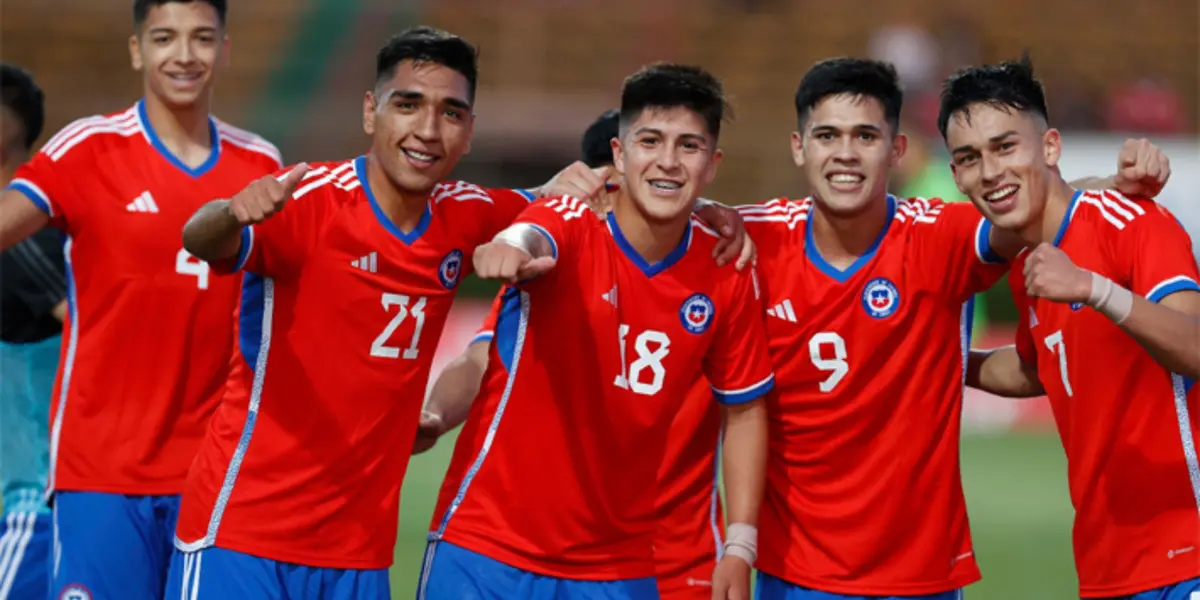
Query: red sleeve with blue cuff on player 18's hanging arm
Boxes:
[{"xmin": 703, "ymin": 268, "xmax": 775, "ymax": 404}]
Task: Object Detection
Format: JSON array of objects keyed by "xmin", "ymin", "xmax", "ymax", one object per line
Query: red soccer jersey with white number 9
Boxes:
[{"xmin": 740, "ymin": 197, "xmax": 1006, "ymax": 596}]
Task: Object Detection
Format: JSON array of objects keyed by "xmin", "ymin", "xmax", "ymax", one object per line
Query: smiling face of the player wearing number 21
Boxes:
[{"xmin": 362, "ymin": 60, "xmax": 474, "ymax": 193}]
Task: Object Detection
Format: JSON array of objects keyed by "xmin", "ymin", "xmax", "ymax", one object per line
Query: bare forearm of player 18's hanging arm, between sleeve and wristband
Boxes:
[{"xmin": 722, "ymin": 398, "xmax": 767, "ymax": 526}]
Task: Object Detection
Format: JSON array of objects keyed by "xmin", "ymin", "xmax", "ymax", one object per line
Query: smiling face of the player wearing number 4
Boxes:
[{"xmin": 130, "ymin": 2, "xmax": 229, "ymax": 107}]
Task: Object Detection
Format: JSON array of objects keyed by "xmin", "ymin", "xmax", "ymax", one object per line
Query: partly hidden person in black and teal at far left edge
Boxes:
[{"xmin": 0, "ymin": 65, "xmax": 59, "ymax": 599}]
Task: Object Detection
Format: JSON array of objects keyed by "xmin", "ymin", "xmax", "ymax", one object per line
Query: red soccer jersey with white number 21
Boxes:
[{"xmin": 176, "ymin": 157, "xmax": 528, "ymax": 569}]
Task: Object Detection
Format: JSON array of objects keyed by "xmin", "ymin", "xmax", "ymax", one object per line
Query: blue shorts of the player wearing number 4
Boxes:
[{"xmin": 50, "ymin": 492, "xmax": 179, "ymax": 600}]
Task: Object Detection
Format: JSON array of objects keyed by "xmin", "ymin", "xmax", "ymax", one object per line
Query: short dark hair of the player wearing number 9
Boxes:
[{"xmin": 796, "ymin": 56, "xmax": 904, "ymax": 133}]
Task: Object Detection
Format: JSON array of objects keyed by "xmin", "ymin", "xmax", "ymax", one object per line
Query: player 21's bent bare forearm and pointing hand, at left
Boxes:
[{"xmin": 184, "ymin": 163, "xmax": 308, "ymax": 263}]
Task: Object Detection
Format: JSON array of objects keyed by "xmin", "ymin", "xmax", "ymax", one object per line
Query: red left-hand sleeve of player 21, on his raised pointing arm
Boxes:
[{"xmin": 219, "ymin": 167, "xmax": 332, "ymax": 277}]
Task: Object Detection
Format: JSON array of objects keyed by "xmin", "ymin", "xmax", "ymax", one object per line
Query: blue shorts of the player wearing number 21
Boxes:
[{"xmin": 167, "ymin": 548, "xmax": 391, "ymax": 600}]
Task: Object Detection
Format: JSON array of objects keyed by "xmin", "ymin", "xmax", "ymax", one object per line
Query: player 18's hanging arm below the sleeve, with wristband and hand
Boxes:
[{"xmin": 713, "ymin": 397, "xmax": 767, "ymax": 600}]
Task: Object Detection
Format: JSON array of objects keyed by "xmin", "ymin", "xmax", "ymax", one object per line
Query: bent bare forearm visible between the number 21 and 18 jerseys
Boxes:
[{"xmin": 413, "ymin": 340, "xmax": 490, "ymax": 454}]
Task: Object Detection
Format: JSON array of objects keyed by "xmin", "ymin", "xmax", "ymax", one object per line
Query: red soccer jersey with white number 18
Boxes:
[{"xmin": 432, "ymin": 198, "xmax": 774, "ymax": 581}]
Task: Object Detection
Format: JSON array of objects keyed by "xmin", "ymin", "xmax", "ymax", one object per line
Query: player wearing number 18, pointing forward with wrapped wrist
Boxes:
[{"xmin": 418, "ymin": 65, "xmax": 774, "ymax": 600}]
